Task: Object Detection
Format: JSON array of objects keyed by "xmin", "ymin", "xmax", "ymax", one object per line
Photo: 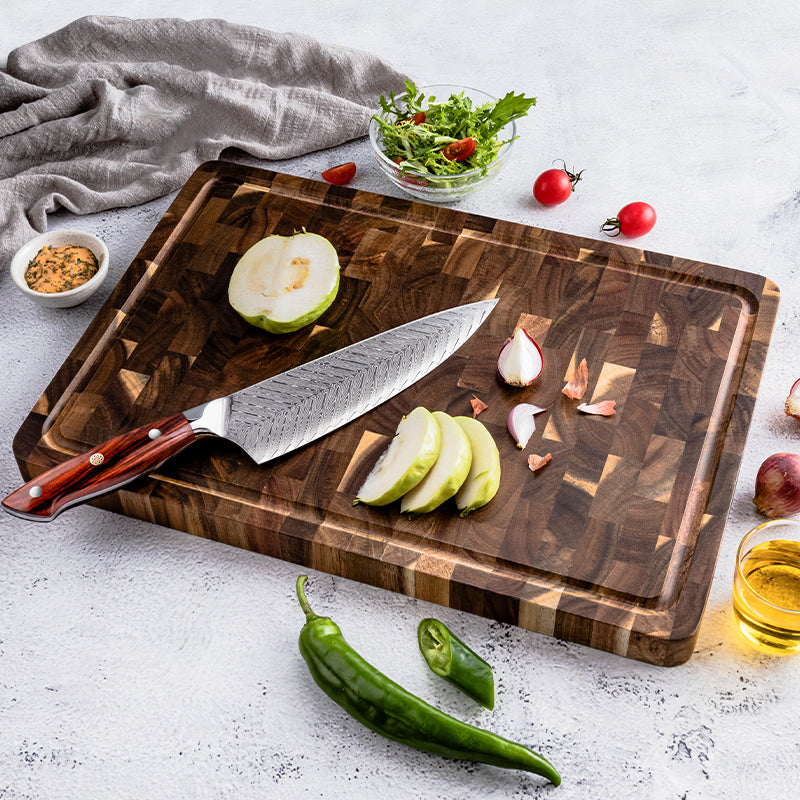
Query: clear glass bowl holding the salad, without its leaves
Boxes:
[{"xmin": 369, "ymin": 84, "xmax": 517, "ymax": 203}]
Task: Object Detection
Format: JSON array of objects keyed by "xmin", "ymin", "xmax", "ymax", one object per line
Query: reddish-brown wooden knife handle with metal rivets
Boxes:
[{"xmin": 2, "ymin": 414, "xmax": 196, "ymax": 522}]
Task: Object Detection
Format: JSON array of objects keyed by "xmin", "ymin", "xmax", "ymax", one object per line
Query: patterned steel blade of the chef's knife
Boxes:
[{"xmin": 216, "ymin": 300, "xmax": 497, "ymax": 464}]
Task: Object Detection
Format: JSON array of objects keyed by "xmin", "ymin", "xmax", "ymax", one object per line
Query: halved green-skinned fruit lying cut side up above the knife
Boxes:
[{"xmin": 228, "ymin": 231, "xmax": 339, "ymax": 333}]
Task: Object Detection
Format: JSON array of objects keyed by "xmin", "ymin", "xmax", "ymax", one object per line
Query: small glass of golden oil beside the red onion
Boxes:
[{"xmin": 733, "ymin": 519, "xmax": 800, "ymax": 654}]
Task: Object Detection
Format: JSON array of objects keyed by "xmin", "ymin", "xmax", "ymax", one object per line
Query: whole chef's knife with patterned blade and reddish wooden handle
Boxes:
[{"xmin": 2, "ymin": 300, "xmax": 497, "ymax": 521}]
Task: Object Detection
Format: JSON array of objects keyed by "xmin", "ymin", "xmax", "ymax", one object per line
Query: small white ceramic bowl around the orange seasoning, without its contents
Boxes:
[{"xmin": 9, "ymin": 229, "xmax": 108, "ymax": 308}]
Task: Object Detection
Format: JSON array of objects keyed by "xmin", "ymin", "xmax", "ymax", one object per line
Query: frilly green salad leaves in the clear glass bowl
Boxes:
[{"xmin": 374, "ymin": 80, "xmax": 536, "ymax": 175}]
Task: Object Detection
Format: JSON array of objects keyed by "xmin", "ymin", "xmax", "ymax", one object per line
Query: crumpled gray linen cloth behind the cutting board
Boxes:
[{"xmin": 0, "ymin": 16, "xmax": 404, "ymax": 268}]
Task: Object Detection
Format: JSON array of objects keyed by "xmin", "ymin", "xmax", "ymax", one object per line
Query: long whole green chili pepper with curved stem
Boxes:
[{"xmin": 296, "ymin": 575, "xmax": 561, "ymax": 786}]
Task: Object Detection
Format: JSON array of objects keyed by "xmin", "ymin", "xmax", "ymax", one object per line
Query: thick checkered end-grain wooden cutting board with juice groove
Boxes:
[{"xmin": 14, "ymin": 161, "xmax": 778, "ymax": 665}]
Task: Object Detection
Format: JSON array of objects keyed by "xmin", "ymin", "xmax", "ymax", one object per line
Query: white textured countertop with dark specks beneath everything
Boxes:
[{"xmin": 0, "ymin": 0, "xmax": 800, "ymax": 800}]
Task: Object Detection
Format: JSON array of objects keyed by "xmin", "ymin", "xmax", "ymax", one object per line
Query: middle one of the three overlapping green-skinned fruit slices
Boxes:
[{"xmin": 400, "ymin": 411, "xmax": 472, "ymax": 514}]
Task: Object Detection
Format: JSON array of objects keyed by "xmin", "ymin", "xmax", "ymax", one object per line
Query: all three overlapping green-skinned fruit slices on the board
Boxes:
[{"xmin": 355, "ymin": 406, "xmax": 500, "ymax": 517}]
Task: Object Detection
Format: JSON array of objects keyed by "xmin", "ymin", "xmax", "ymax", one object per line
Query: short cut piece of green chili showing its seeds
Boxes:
[{"xmin": 417, "ymin": 618, "xmax": 494, "ymax": 711}]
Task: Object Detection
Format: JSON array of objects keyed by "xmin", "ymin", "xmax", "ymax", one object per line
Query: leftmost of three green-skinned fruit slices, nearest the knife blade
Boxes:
[{"xmin": 354, "ymin": 406, "xmax": 442, "ymax": 506}]
